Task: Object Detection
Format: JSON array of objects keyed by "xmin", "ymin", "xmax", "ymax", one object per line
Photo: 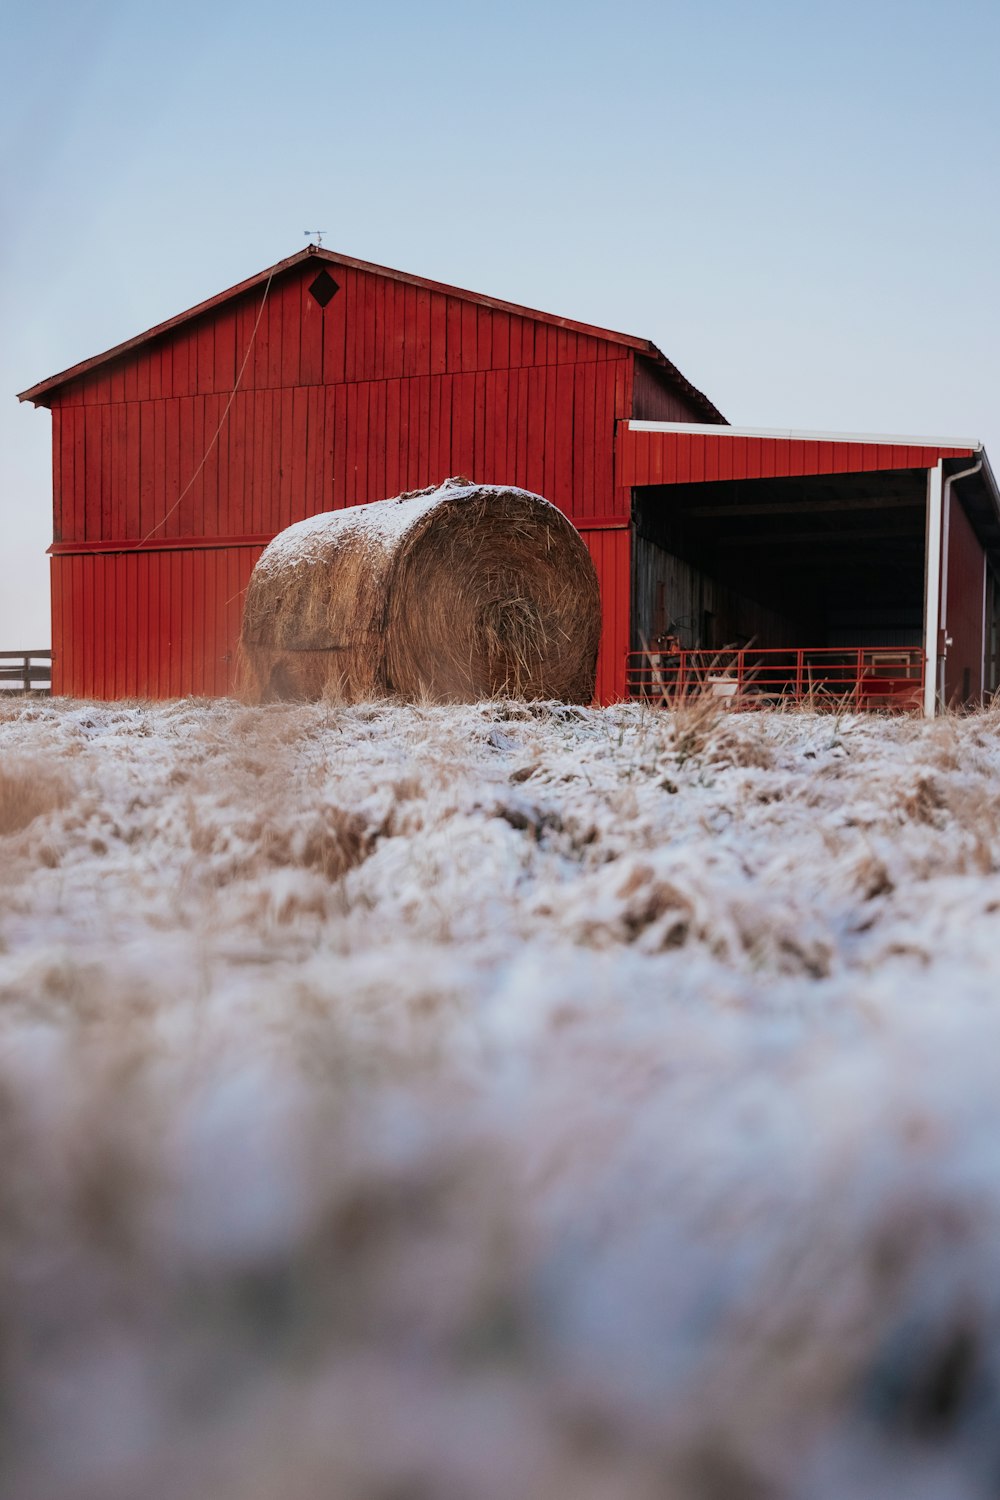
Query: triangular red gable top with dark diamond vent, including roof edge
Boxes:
[{"xmin": 18, "ymin": 246, "xmax": 724, "ymax": 422}]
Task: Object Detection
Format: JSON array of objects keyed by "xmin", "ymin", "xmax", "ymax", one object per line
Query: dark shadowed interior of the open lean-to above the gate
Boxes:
[{"xmin": 633, "ymin": 470, "xmax": 927, "ymax": 651}]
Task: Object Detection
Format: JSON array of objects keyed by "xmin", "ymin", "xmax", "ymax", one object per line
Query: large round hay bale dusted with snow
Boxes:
[{"xmin": 241, "ymin": 479, "xmax": 601, "ymax": 704}]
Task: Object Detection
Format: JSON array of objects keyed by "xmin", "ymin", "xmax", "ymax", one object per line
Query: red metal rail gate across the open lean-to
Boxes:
[{"xmin": 625, "ymin": 647, "xmax": 924, "ymax": 713}]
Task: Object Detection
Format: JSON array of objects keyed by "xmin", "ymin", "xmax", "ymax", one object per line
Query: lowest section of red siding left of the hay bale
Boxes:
[{"xmin": 51, "ymin": 545, "xmax": 261, "ymax": 699}]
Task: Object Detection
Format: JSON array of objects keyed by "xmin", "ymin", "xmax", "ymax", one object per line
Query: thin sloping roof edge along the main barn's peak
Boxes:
[{"xmin": 18, "ymin": 245, "xmax": 726, "ymax": 423}]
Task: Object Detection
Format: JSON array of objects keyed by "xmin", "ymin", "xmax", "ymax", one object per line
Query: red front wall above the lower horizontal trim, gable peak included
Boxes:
[{"xmin": 46, "ymin": 266, "xmax": 633, "ymax": 545}]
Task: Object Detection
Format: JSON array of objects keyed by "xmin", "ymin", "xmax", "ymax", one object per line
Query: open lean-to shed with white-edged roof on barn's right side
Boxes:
[{"xmin": 616, "ymin": 420, "xmax": 1000, "ymax": 710}]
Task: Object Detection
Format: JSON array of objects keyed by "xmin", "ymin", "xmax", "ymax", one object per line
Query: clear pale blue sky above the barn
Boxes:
[{"xmin": 0, "ymin": 0, "xmax": 1000, "ymax": 650}]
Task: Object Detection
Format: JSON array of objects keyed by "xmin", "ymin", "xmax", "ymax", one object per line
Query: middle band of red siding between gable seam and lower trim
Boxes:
[{"xmin": 52, "ymin": 362, "xmax": 628, "ymax": 545}]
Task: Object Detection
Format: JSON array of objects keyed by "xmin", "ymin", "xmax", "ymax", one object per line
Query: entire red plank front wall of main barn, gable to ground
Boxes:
[{"xmin": 44, "ymin": 263, "xmax": 665, "ymax": 699}]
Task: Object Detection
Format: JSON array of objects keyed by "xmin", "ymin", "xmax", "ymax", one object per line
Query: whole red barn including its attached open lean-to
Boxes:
[{"xmin": 21, "ymin": 246, "xmax": 1000, "ymax": 704}]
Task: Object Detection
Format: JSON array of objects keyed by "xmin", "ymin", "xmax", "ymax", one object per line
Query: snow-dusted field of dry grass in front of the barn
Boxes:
[{"xmin": 0, "ymin": 701, "xmax": 1000, "ymax": 1500}]
